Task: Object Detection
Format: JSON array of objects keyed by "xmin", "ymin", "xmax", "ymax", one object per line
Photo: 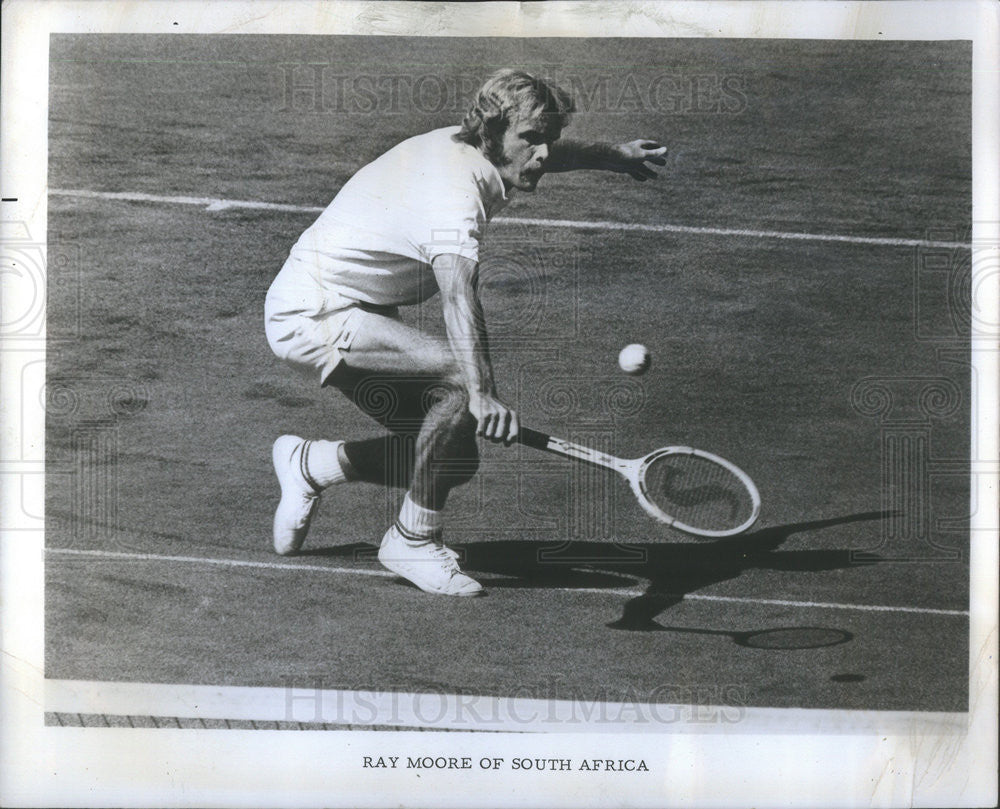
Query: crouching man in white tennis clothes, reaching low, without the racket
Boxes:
[{"xmin": 265, "ymin": 70, "xmax": 666, "ymax": 596}]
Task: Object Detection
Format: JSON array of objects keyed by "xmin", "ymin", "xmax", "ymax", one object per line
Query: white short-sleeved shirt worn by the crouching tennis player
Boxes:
[{"xmin": 268, "ymin": 126, "xmax": 508, "ymax": 315}]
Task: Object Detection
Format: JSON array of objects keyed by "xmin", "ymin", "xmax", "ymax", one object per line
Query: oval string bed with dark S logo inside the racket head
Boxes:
[{"xmin": 643, "ymin": 453, "xmax": 754, "ymax": 531}]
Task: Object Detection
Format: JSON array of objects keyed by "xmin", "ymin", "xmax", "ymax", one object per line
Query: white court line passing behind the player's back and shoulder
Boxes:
[{"xmin": 49, "ymin": 188, "xmax": 972, "ymax": 250}]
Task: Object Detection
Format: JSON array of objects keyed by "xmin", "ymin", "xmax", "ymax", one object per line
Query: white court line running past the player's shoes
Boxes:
[{"xmin": 45, "ymin": 546, "xmax": 969, "ymax": 616}]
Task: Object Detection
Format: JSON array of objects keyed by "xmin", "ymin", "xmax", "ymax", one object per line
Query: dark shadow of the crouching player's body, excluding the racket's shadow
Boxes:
[{"xmin": 456, "ymin": 511, "xmax": 886, "ymax": 631}]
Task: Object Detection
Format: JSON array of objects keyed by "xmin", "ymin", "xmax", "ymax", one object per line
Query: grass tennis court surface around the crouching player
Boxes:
[{"xmin": 46, "ymin": 36, "xmax": 971, "ymax": 711}]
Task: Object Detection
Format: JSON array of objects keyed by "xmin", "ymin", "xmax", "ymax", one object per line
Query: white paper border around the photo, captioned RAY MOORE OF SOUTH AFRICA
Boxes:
[{"xmin": 0, "ymin": 0, "xmax": 1000, "ymax": 807}]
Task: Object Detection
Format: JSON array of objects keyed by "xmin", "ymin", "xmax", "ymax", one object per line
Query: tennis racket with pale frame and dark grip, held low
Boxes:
[{"xmin": 517, "ymin": 427, "xmax": 760, "ymax": 537}]
